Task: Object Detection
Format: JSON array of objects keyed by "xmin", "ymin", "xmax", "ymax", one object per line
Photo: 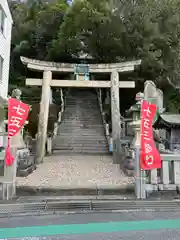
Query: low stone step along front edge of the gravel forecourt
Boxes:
[{"xmin": 16, "ymin": 184, "xmax": 134, "ymax": 196}]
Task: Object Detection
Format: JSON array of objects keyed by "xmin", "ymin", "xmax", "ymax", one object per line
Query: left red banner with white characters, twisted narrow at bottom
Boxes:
[{"xmin": 6, "ymin": 98, "xmax": 30, "ymax": 166}]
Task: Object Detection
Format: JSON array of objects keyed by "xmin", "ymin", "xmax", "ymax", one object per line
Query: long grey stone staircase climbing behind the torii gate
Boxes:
[{"xmin": 53, "ymin": 89, "xmax": 109, "ymax": 154}]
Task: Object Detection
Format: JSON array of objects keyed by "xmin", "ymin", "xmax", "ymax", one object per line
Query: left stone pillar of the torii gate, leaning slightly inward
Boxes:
[{"xmin": 36, "ymin": 71, "xmax": 52, "ymax": 163}]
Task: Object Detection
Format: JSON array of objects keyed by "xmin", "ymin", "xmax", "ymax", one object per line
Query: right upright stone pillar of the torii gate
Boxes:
[{"xmin": 111, "ymin": 71, "xmax": 121, "ymax": 164}]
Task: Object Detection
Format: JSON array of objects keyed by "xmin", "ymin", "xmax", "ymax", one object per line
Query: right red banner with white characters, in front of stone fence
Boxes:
[{"xmin": 140, "ymin": 101, "xmax": 162, "ymax": 170}]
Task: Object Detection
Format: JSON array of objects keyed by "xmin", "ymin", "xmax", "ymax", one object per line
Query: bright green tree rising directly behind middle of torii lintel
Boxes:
[{"xmin": 52, "ymin": 0, "xmax": 122, "ymax": 62}]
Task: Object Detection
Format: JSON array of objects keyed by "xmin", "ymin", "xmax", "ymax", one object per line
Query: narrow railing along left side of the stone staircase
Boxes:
[{"xmin": 47, "ymin": 88, "xmax": 65, "ymax": 154}]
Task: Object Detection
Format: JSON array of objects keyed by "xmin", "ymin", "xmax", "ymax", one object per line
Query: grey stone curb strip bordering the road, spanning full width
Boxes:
[{"xmin": 0, "ymin": 199, "xmax": 180, "ymax": 218}]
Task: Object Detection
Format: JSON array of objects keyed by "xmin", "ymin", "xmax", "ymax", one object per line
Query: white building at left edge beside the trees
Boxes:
[{"xmin": 0, "ymin": 0, "xmax": 13, "ymax": 144}]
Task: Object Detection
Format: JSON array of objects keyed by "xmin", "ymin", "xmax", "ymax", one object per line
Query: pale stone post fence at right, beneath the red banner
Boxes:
[{"xmin": 144, "ymin": 153, "xmax": 180, "ymax": 195}]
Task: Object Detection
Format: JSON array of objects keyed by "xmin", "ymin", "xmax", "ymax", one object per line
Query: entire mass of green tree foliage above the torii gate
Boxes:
[{"xmin": 10, "ymin": 0, "xmax": 180, "ymax": 110}]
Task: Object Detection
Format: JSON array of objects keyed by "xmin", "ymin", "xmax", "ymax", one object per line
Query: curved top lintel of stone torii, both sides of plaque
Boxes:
[{"xmin": 21, "ymin": 57, "xmax": 141, "ymax": 73}]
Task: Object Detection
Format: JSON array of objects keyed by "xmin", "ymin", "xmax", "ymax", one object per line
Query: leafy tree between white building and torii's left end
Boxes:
[{"xmin": 10, "ymin": 0, "xmax": 68, "ymax": 85}]
